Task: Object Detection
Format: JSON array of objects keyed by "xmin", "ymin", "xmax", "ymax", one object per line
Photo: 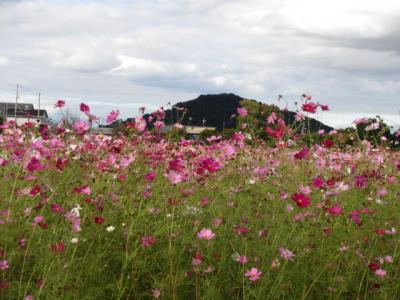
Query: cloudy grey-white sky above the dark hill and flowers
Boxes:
[{"xmin": 0, "ymin": 0, "xmax": 400, "ymax": 127}]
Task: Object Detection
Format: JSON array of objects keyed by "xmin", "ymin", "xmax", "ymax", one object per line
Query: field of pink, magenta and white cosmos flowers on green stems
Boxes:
[{"xmin": 0, "ymin": 102, "xmax": 400, "ymax": 299}]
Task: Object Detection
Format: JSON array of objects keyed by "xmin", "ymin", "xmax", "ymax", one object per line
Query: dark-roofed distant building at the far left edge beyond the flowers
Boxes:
[{"xmin": 0, "ymin": 102, "xmax": 49, "ymax": 125}]
